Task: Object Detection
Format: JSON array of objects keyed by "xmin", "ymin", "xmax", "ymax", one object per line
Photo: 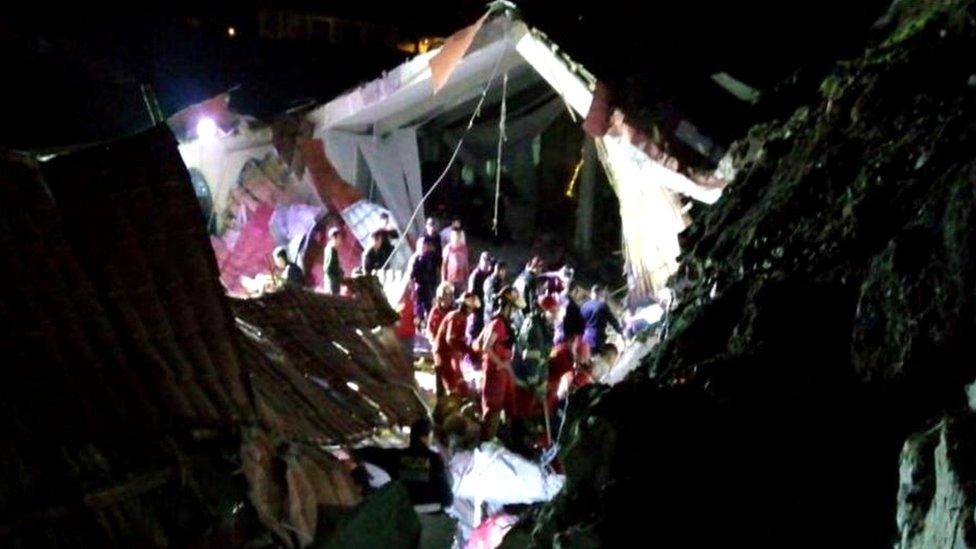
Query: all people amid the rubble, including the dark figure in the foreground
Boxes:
[{"xmin": 264, "ymin": 212, "xmax": 626, "ymax": 536}]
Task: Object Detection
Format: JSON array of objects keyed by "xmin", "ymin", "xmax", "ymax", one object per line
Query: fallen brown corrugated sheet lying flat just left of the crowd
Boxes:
[{"xmin": 232, "ymin": 278, "xmax": 424, "ymax": 443}]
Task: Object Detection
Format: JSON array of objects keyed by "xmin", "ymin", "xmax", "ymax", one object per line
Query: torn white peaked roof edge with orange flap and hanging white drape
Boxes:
[{"xmin": 308, "ymin": 10, "xmax": 724, "ymax": 293}]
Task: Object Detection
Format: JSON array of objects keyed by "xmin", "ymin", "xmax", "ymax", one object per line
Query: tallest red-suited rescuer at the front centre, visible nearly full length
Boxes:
[{"xmin": 476, "ymin": 286, "xmax": 525, "ymax": 440}]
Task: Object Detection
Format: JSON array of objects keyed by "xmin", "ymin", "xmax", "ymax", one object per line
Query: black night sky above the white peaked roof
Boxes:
[{"xmin": 0, "ymin": 0, "xmax": 886, "ymax": 148}]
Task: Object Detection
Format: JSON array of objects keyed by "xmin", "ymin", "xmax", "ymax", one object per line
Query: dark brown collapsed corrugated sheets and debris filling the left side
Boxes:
[{"xmin": 0, "ymin": 126, "xmax": 425, "ymax": 547}]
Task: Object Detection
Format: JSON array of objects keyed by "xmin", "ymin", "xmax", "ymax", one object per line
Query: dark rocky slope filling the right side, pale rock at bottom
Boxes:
[{"xmin": 512, "ymin": 1, "xmax": 976, "ymax": 547}]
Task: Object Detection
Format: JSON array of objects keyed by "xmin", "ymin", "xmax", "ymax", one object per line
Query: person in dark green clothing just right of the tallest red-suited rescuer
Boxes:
[{"xmin": 513, "ymin": 296, "xmax": 559, "ymax": 418}]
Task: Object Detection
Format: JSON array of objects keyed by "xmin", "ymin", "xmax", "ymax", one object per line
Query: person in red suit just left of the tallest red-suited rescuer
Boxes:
[{"xmin": 431, "ymin": 292, "xmax": 481, "ymax": 399}]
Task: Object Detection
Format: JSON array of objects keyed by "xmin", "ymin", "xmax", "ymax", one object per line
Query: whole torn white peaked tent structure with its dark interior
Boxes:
[{"xmin": 171, "ymin": 9, "xmax": 724, "ymax": 297}]
